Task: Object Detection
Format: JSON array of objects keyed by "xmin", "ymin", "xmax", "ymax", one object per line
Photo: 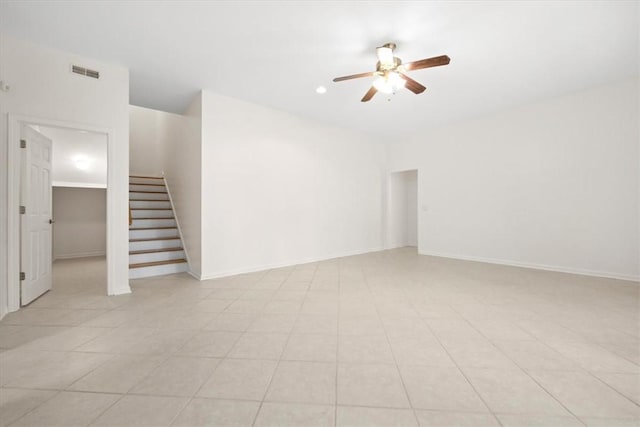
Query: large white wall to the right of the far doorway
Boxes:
[{"xmin": 388, "ymin": 78, "xmax": 640, "ymax": 279}]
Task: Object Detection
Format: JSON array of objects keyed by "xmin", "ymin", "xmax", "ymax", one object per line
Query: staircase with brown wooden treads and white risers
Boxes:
[{"xmin": 129, "ymin": 176, "xmax": 188, "ymax": 279}]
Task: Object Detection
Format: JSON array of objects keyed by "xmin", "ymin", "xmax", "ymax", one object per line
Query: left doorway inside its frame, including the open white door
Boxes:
[{"xmin": 20, "ymin": 124, "xmax": 107, "ymax": 306}]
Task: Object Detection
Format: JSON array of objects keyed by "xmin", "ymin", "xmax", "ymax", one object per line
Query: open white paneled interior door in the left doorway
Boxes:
[{"xmin": 20, "ymin": 125, "xmax": 52, "ymax": 305}]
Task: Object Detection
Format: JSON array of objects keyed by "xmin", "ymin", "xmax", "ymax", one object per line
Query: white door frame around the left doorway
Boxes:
[{"xmin": 7, "ymin": 114, "xmax": 122, "ymax": 312}]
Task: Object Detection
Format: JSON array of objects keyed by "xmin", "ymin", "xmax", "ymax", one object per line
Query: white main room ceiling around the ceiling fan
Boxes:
[{"xmin": 0, "ymin": 0, "xmax": 639, "ymax": 136}]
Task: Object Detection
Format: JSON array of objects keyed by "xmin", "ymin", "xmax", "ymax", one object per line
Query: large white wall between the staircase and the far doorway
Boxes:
[{"xmin": 202, "ymin": 91, "xmax": 384, "ymax": 278}]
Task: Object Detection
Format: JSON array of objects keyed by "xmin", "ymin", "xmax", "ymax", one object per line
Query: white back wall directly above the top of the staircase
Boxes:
[{"xmin": 129, "ymin": 105, "xmax": 164, "ymax": 176}]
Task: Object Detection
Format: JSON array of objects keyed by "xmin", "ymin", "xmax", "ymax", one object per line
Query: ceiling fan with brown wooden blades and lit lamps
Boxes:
[{"xmin": 333, "ymin": 43, "xmax": 451, "ymax": 102}]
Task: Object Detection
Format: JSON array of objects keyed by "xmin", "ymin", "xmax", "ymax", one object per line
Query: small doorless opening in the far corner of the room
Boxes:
[{"xmin": 385, "ymin": 169, "xmax": 419, "ymax": 249}]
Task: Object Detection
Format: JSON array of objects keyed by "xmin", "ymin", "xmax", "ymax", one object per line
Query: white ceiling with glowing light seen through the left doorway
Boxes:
[{"xmin": 34, "ymin": 126, "xmax": 107, "ymax": 188}]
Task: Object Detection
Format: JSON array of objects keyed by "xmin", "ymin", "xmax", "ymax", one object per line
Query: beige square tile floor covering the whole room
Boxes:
[{"xmin": 0, "ymin": 248, "xmax": 640, "ymax": 427}]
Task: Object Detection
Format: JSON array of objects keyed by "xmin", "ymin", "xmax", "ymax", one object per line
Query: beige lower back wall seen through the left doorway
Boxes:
[{"xmin": 53, "ymin": 187, "xmax": 107, "ymax": 260}]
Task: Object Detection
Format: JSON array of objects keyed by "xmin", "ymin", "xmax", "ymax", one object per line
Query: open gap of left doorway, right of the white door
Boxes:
[{"xmin": 43, "ymin": 126, "xmax": 107, "ymax": 300}]
